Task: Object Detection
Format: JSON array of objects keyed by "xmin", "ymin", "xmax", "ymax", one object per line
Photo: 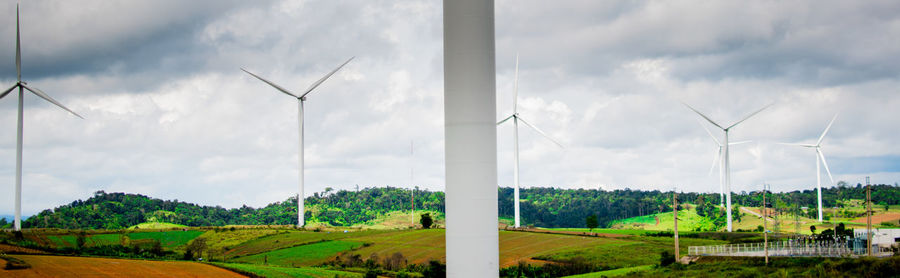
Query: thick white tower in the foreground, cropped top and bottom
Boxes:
[{"xmin": 443, "ymin": 0, "xmax": 500, "ymax": 277}]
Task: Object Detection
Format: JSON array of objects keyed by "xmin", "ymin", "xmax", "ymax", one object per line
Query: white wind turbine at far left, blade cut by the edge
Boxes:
[{"xmin": 0, "ymin": 4, "xmax": 84, "ymax": 231}]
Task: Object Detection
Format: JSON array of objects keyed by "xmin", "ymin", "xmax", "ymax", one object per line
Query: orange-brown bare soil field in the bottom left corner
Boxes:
[{"xmin": 0, "ymin": 255, "xmax": 245, "ymax": 277}]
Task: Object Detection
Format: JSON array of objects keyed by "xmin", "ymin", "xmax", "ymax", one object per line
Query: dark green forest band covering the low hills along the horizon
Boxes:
[{"xmin": 14, "ymin": 182, "xmax": 900, "ymax": 229}]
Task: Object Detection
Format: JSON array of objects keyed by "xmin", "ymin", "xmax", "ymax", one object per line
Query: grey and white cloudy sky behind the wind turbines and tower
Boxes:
[{"xmin": 0, "ymin": 0, "xmax": 900, "ymax": 215}]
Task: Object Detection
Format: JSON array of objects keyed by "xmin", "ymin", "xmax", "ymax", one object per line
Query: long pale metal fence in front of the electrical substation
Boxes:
[{"xmin": 688, "ymin": 241, "xmax": 892, "ymax": 257}]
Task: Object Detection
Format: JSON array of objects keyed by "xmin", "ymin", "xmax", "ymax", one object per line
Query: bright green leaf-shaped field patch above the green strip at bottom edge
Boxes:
[{"xmin": 230, "ymin": 240, "xmax": 363, "ymax": 267}]
